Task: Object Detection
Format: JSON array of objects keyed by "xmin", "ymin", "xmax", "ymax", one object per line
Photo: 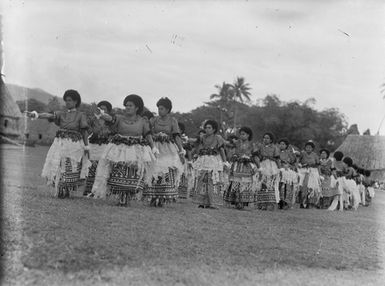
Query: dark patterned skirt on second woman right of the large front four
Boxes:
[{"xmin": 223, "ymin": 160, "xmax": 256, "ymax": 205}]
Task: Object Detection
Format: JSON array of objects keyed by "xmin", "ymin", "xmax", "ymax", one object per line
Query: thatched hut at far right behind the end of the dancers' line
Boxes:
[{"xmin": 337, "ymin": 135, "xmax": 385, "ymax": 182}]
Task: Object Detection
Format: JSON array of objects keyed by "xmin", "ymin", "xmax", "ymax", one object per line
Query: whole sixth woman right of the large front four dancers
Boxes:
[{"xmin": 319, "ymin": 149, "xmax": 339, "ymax": 209}]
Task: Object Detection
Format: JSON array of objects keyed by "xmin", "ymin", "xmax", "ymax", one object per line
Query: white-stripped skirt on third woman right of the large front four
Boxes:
[{"xmin": 256, "ymin": 159, "xmax": 279, "ymax": 208}]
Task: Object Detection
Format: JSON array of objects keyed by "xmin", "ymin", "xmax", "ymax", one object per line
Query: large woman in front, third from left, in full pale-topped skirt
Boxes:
[{"xmin": 92, "ymin": 94, "xmax": 159, "ymax": 206}]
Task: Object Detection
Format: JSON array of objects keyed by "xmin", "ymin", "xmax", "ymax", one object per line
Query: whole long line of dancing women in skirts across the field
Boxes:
[{"xmin": 26, "ymin": 90, "xmax": 374, "ymax": 211}]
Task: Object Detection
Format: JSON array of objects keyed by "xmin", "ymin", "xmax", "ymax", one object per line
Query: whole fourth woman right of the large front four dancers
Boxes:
[{"xmin": 278, "ymin": 139, "xmax": 298, "ymax": 209}]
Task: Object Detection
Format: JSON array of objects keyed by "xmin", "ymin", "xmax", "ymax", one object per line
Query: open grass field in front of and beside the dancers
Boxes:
[{"xmin": 1, "ymin": 145, "xmax": 385, "ymax": 285}]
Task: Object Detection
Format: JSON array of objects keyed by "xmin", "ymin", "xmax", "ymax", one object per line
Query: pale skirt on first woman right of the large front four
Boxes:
[{"xmin": 192, "ymin": 155, "xmax": 224, "ymax": 206}]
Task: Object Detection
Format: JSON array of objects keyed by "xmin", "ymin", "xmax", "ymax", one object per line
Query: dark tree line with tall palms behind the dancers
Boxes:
[{"xmin": 17, "ymin": 77, "xmax": 370, "ymax": 151}]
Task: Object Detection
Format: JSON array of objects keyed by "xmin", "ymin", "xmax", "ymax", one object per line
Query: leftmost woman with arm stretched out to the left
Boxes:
[{"xmin": 27, "ymin": 89, "xmax": 89, "ymax": 198}]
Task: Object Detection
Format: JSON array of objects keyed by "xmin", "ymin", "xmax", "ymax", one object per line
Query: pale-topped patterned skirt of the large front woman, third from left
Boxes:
[{"xmin": 92, "ymin": 143, "xmax": 155, "ymax": 198}]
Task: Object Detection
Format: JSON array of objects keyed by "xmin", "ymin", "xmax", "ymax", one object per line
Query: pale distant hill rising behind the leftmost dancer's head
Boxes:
[{"xmin": 6, "ymin": 83, "xmax": 64, "ymax": 105}]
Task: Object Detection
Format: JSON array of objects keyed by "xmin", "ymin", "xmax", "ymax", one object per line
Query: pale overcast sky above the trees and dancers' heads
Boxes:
[{"xmin": 0, "ymin": 0, "xmax": 385, "ymax": 135}]
